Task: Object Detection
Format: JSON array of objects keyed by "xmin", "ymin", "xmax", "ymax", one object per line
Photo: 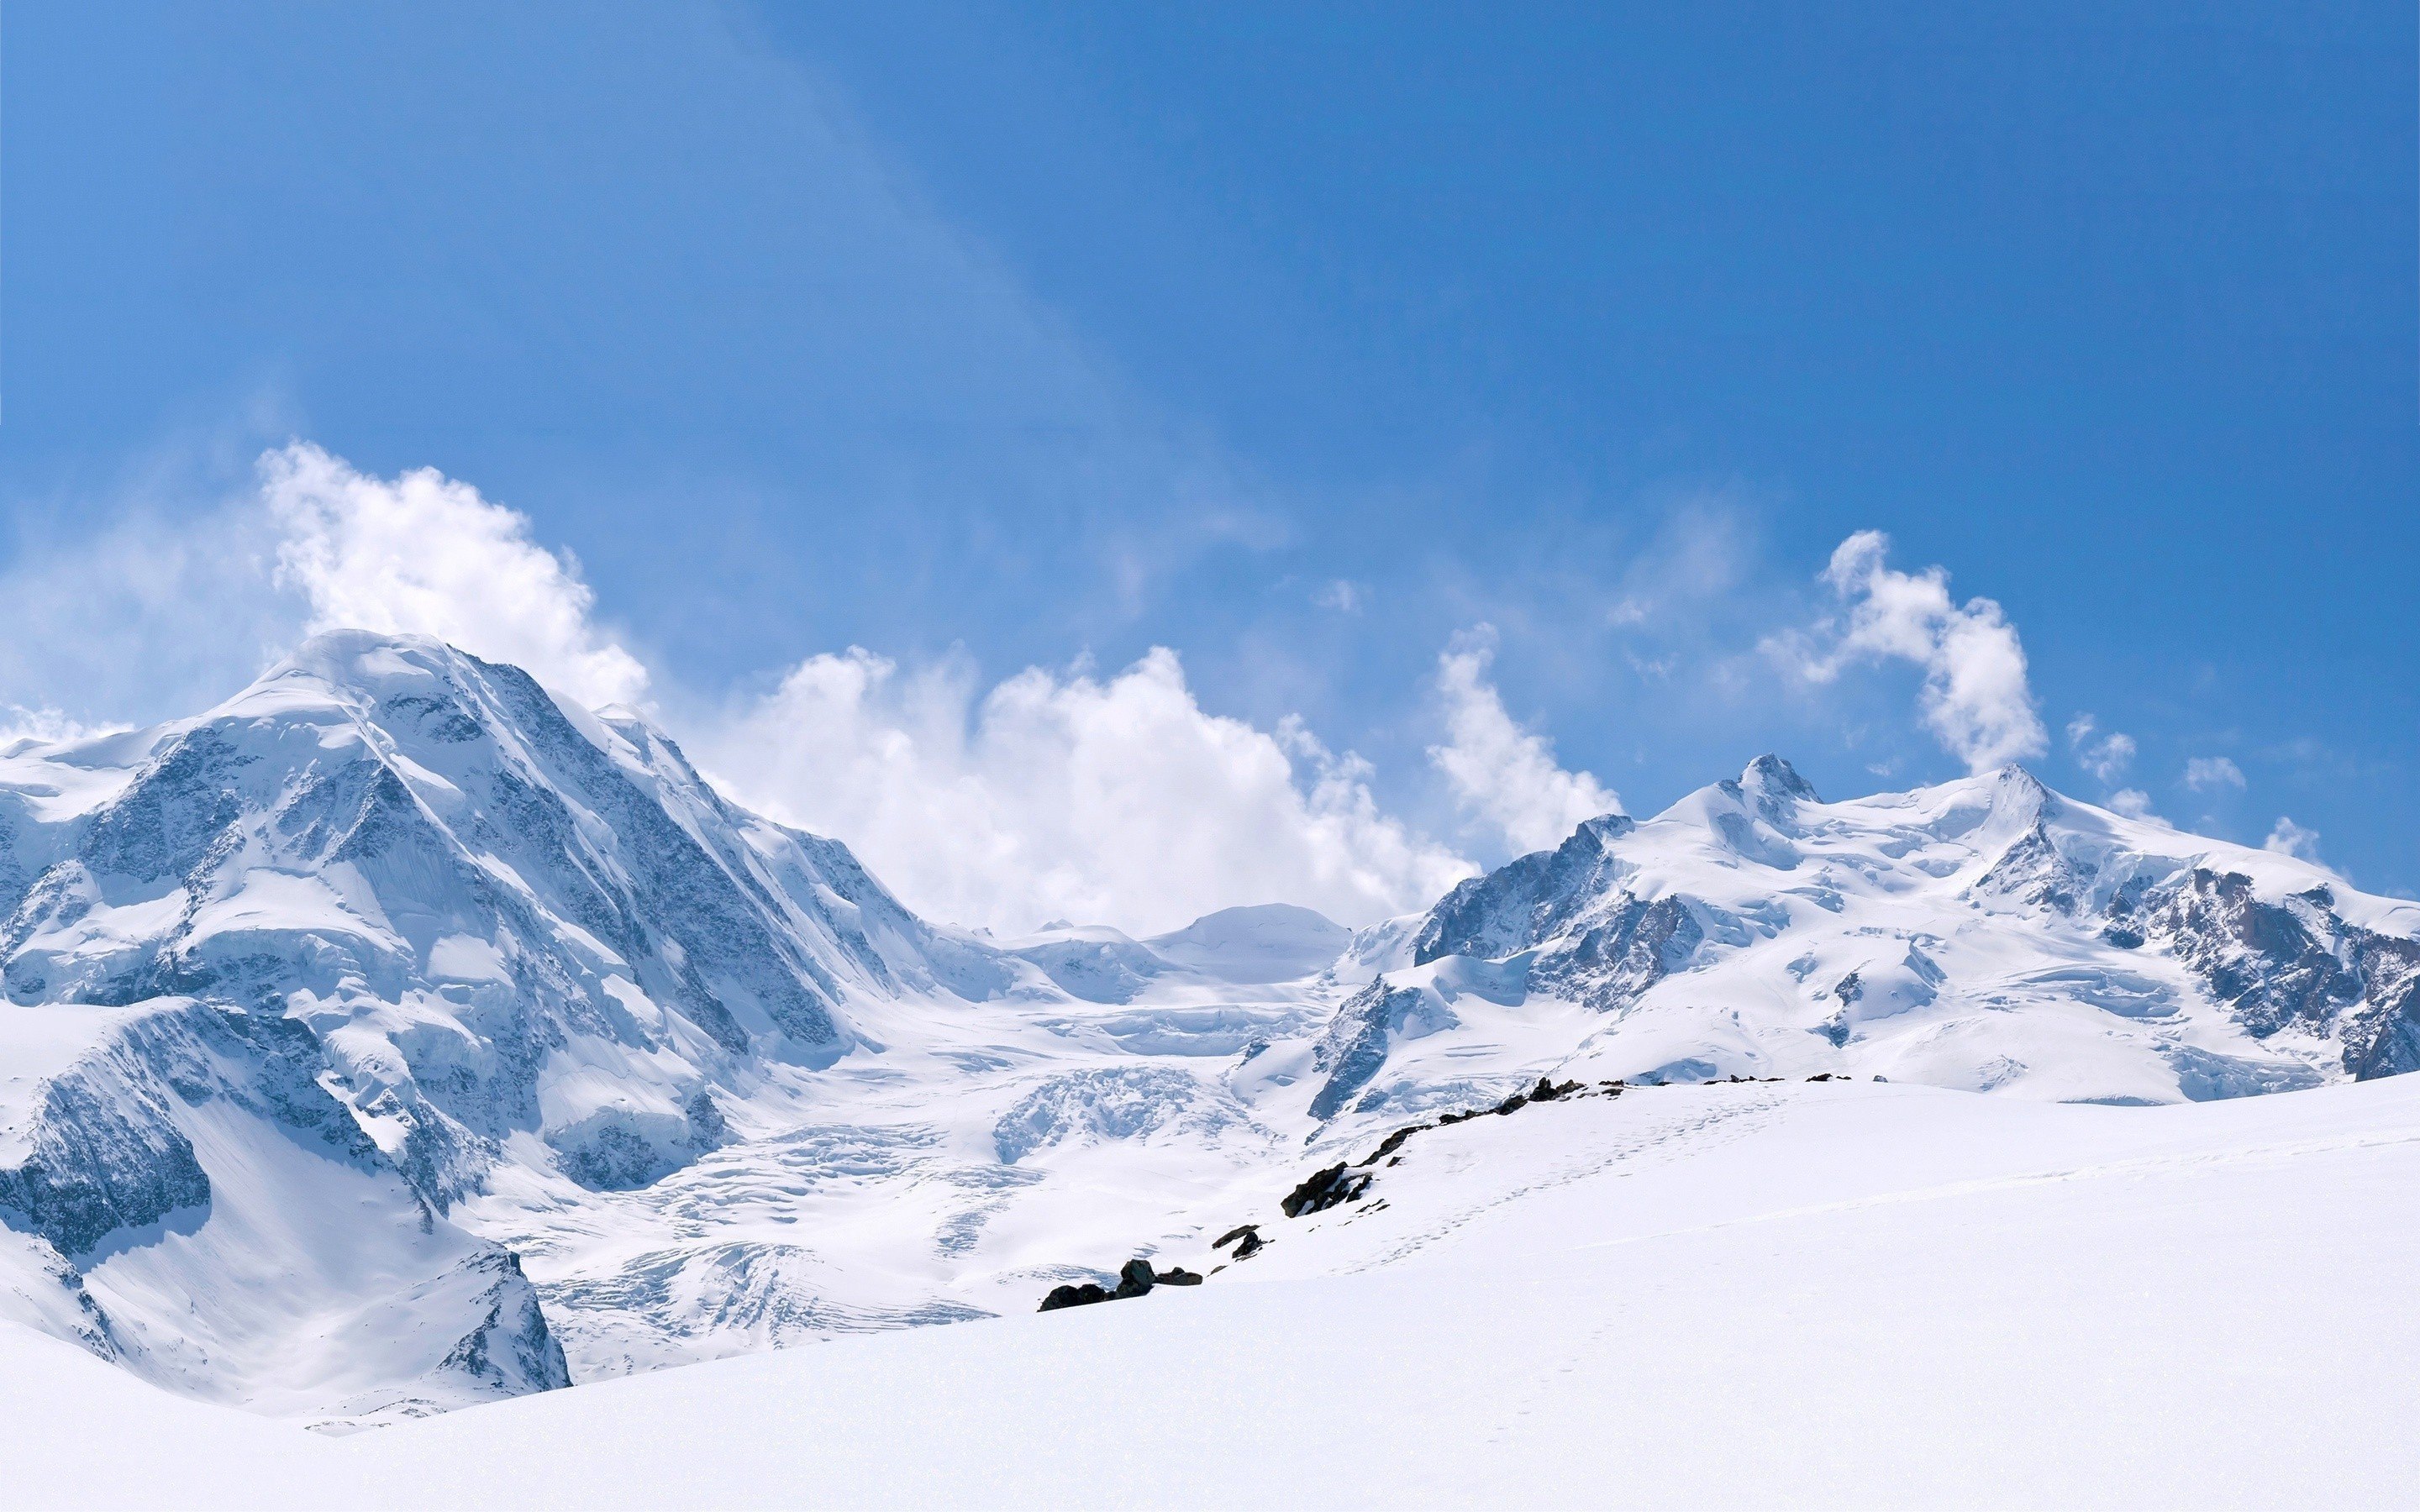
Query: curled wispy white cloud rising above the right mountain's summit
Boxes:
[{"xmin": 1765, "ymin": 530, "xmax": 2049, "ymax": 772}]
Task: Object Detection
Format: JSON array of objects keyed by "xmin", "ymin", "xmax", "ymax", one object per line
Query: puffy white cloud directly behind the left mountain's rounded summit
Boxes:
[{"xmin": 261, "ymin": 443, "xmax": 646, "ymax": 706}]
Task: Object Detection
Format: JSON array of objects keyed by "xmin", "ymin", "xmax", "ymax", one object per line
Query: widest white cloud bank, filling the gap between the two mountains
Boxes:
[{"xmin": 697, "ymin": 648, "xmax": 1471, "ymax": 934}]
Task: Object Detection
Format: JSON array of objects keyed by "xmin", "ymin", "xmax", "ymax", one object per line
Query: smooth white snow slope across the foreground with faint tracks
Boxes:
[{"xmin": 0, "ymin": 1079, "xmax": 2420, "ymax": 1507}]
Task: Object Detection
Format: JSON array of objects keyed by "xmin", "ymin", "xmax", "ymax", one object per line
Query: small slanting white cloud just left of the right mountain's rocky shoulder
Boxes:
[{"xmin": 1428, "ymin": 627, "xmax": 1622, "ymax": 852}]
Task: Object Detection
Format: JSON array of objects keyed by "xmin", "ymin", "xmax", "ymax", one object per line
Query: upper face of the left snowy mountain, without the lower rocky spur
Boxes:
[{"xmin": 0, "ymin": 634, "xmax": 1007, "ymax": 1210}]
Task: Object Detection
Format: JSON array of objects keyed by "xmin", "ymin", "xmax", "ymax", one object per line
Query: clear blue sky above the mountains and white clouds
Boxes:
[{"xmin": 0, "ymin": 3, "xmax": 2420, "ymax": 921}]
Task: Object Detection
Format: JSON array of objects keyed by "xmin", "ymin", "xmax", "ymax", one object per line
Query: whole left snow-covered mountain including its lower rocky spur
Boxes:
[{"xmin": 0, "ymin": 634, "xmax": 1045, "ymax": 1415}]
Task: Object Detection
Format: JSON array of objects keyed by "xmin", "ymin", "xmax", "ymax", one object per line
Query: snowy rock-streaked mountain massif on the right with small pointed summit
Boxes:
[{"xmin": 1312, "ymin": 757, "xmax": 2420, "ymax": 1116}]
